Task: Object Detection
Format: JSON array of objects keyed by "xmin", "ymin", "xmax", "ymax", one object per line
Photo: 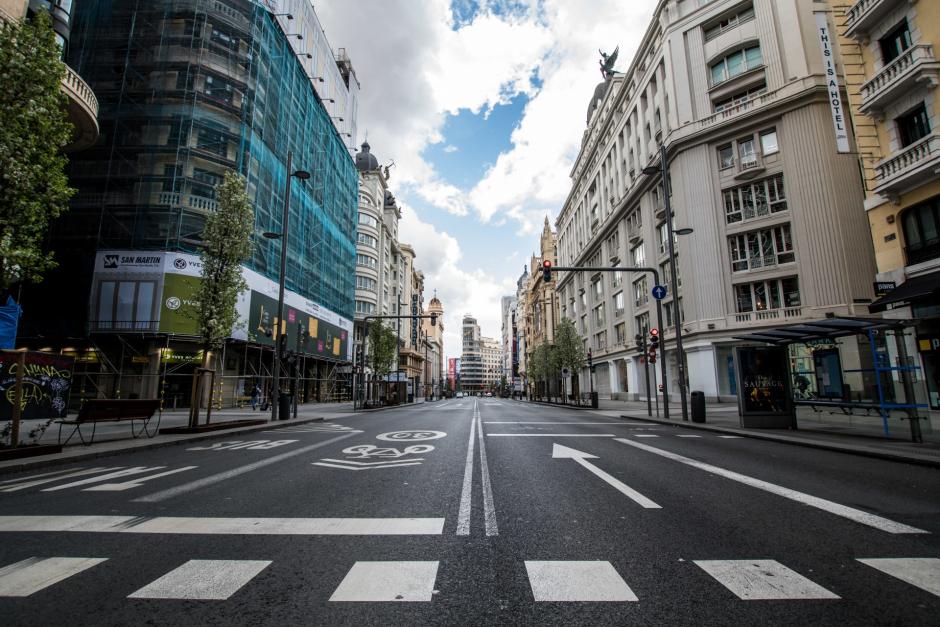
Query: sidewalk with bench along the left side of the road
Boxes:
[{"xmin": 0, "ymin": 403, "xmax": 358, "ymax": 474}]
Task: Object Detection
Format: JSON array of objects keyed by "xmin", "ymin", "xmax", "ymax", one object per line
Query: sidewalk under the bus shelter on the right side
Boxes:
[{"xmin": 599, "ymin": 400, "xmax": 940, "ymax": 468}]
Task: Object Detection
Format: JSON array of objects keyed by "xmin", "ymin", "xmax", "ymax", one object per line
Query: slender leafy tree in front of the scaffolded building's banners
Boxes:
[{"xmin": 190, "ymin": 171, "xmax": 255, "ymax": 426}]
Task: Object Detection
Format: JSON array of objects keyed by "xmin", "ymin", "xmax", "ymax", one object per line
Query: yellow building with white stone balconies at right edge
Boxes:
[{"xmin": 830, "ymin": 0, "xmax": 940, "ymax": 410}]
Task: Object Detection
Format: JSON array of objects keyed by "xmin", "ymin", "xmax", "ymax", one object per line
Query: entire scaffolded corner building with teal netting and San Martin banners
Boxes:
[{"xmin": 21, "ymin": 0, "xmax": 359, "ymax": 407}]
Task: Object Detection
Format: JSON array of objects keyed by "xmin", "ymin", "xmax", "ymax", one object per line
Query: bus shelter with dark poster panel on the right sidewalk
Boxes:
[{"xmin": 735, "ymin": 317, "xmax": 929, "ymax": 442}]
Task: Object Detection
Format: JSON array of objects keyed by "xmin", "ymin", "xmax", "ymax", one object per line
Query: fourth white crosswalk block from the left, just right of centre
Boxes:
[{"xmin": 525, "ymin": 561, "xmax": 638, "ymax": 601}]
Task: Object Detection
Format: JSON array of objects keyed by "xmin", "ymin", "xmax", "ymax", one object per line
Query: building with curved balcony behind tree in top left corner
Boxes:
[{"xmin": 0, "ymin": 0, "xmax": 99, "ymax": 153}]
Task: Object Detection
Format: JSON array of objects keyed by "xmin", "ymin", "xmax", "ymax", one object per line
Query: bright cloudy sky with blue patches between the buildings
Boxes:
[{"xmin": 315, "ymin": 0, "xmax": 656, "ymax": 357}]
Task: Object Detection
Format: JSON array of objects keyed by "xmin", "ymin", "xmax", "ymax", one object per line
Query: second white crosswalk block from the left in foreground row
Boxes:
[{"xmin": 127, "ymin": 560, "xmax": 271, "ymax": 601}]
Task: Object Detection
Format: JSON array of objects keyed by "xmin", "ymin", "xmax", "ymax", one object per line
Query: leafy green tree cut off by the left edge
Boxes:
[{"xmin": 0, "ymin": 11, "xmax": 75, "ymax": 294}]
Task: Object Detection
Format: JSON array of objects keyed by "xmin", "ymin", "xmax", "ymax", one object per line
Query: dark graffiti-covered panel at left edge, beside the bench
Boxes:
[{"xmin": 0, "ymin": 353, "xmax": 75, "ymax": 420}]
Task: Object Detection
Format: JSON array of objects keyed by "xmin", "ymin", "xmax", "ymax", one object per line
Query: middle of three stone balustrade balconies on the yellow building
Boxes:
[{"xmin": 859, "ymin": 44, "xmax": 940, "ymax": 120}]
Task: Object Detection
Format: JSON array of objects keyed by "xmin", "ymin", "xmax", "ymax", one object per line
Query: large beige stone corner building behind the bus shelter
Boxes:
[{"xmin": 556, "ymin": 0, "xmax": 876, "ymax": 400}]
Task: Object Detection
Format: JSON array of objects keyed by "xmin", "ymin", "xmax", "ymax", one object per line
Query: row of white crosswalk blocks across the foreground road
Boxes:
[{"xmin": 0, "ymin": 557, "xmax": 940, "ymax": 603}]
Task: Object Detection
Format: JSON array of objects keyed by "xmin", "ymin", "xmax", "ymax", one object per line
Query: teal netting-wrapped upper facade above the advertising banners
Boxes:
[{"xmin": 62, "ymin": 0, "xmax": 358, "ymax": 320}]
